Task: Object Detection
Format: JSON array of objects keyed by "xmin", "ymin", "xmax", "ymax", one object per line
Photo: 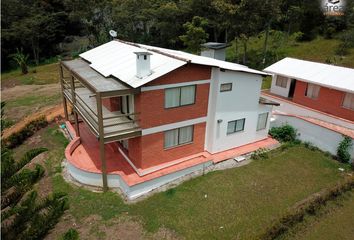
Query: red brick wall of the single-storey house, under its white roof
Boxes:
[{"xmin": 293, "ymin": 81, "xmax": 354, "ymax": 121}]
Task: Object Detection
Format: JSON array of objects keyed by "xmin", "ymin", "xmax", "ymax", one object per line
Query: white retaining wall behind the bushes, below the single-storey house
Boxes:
[{"xmin": 271, "ymin": 115, "xmax": 354, "ymax": 159}]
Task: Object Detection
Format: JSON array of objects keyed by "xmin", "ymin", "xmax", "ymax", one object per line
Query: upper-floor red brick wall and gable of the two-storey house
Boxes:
[{"xmin": 134, "ymin": 64, "xmax": 210, "ymax": 129}]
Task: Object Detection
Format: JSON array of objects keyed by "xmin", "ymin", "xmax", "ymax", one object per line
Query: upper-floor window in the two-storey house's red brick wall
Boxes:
[{"xmin": 165, "ymin": 85, "xmax": 195, "ymax": 108}]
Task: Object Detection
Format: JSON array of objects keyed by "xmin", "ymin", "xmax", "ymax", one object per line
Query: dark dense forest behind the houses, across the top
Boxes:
[{"xmin": 1, "ymin": 0, "xmax": 354, "ymax": 71}]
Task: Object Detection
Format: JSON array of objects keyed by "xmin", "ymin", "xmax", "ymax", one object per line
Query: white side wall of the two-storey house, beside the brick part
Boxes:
[{"xmin": 205, "ymin": 68, "xmax": 272, "ymax": 153}]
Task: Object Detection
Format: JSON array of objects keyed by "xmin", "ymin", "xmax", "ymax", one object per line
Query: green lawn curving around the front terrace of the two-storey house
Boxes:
[{"xmin": 22, "ymin": 124, "xmax": 343, "ymax": 239}]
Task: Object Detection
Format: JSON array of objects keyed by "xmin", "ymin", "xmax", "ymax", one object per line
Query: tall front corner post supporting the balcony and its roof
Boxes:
[{"xmin": 96, "ymin": 92, "xmax": 108, "ymax": 191}]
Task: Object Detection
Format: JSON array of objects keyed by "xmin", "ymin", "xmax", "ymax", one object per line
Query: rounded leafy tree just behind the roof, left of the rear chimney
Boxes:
[{"xmin": 180, "ymin": 16, "xmax": 209, "ymax": 53}]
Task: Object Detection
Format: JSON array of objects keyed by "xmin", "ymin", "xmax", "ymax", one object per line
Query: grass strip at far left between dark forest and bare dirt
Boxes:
[{"xmin": 1, "ymin": 63, "xmax": 59, "ymax": 85}]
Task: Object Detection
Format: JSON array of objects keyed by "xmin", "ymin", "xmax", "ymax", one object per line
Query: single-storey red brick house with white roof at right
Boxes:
[{"xmin": 264, "ymin": 58, "xmax": 354, "ymax": 121}]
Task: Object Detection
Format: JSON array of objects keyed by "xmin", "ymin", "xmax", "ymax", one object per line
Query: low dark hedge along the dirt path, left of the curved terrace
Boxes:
[{"xmin": 4, "ymin": 116, "xmax": 48, "ymax": 148}]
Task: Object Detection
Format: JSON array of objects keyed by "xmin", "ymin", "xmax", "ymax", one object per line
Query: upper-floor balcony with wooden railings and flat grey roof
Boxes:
[{"xmin": 61, "ymin": 60, "xmax": 141, "ymax": 143}]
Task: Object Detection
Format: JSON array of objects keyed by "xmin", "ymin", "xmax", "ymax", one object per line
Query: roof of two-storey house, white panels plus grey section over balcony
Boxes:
[{"xmin": 63, "ymin": 40, "xmax": 268, "ymax": 92}]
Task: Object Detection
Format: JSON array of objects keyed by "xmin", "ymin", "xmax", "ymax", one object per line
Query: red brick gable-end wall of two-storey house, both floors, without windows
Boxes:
[{"xmin": 128, "ymin": 64, "xmax": 211, "ymax": 168}]
